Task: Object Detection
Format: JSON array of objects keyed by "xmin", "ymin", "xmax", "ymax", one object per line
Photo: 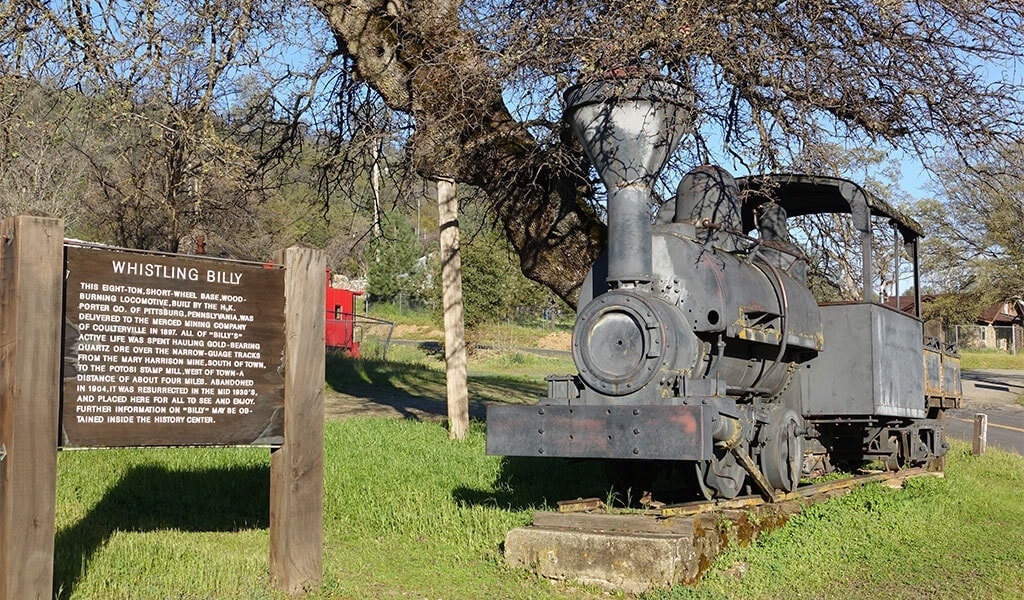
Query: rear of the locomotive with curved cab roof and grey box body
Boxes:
[{"xmin": 739, "ymin": 174, "xmax": 963, "ymax": 470}]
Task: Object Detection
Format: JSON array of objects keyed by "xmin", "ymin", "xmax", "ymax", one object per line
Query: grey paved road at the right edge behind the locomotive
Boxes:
[{"xmin": 946, "ymin": 370, "xmax": 1024, "ymax": 455}]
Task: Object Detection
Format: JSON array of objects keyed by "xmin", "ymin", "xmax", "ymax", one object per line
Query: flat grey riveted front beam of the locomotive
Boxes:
[{"xmin": 487, "ymin": 404, "xmax": 718, "ymax": 461}]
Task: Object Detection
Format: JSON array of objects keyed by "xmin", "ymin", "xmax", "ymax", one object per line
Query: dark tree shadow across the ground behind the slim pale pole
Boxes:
[{"xmin": 326, "ymin": 348, "xmax": 546, "ymax": 420}]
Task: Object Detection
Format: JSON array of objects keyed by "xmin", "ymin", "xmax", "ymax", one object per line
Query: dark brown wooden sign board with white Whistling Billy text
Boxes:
[{"xmin": 60, "ymin": 244, "xmax": 285, "ymax": 447}]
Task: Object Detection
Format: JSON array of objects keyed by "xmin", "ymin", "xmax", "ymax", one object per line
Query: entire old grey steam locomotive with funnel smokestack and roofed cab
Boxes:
[{"xmin": 487, "ymin": 79, "xmax": 961, "ymax": 499}]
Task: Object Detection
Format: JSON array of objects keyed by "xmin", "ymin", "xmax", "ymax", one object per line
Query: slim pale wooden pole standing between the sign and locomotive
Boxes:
[{"xmin": 434, "ymin": 178, "xmax": 469, "ymax": 439}]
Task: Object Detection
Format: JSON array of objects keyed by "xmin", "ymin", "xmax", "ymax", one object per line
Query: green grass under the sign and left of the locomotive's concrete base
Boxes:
[{"xmin": 54, "ymin": 419, "xmax": 599, "ymax": 600}]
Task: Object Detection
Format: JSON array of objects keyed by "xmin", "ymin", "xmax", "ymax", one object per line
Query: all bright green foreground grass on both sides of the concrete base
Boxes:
[{"xmin": 55, "ymin": 419, "xmax": 1024, "ymax": 600}]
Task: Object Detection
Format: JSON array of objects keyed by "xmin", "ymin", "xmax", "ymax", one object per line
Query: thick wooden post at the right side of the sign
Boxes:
[{"xmin": 270, "ymin": 248, "xmax": 327, "ymax": 594}]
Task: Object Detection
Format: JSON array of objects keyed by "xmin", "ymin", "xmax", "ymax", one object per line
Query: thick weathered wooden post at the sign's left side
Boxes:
[{"xmin": 0, "ymin": 215, "xmax": 63, "ymax": 600}]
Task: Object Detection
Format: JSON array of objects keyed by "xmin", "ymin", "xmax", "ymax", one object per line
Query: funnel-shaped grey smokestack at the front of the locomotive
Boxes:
[{"xmin": 565, "ymin": 79, "xmax": 692, "ymax": 287}]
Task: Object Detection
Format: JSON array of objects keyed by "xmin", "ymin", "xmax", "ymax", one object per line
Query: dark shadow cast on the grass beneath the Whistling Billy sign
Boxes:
[{"xmin": 53, "ymin": 466, "xmax": 270, "ymax": 600}]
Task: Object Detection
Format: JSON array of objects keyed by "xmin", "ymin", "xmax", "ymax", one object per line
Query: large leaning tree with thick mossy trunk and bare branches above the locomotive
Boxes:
[{"xmin": 312, "ymin": 0, "xmax": 1024, "ymax": 302}]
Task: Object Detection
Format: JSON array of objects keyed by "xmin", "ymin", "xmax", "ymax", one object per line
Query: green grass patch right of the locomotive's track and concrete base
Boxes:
[{"xmin": 652, "ymin": 443, "xmax": 1024, "ymax": 600}]
